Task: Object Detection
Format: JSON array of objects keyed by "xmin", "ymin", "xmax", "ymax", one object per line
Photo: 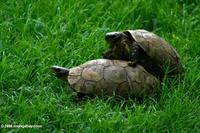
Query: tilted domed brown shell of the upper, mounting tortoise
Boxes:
[{"xmin": 125, "ymin": 29, "xmax": 182, "ymax": 74}]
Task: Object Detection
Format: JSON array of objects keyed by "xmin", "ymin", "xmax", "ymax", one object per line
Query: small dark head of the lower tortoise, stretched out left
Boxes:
[{"xmin": 50, "ymin": 66, "xmax": 69, "ymax": 80}]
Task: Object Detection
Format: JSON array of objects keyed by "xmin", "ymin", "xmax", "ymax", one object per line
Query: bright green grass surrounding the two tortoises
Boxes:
[{"xmin": 0, "ymin": 0, "xmax": 200, "ymax": 133}]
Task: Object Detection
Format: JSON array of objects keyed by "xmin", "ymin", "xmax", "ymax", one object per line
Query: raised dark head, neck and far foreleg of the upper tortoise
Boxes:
[{"xmin": 103, "ymin": 31, "xmax": 134, "ymax": 60}]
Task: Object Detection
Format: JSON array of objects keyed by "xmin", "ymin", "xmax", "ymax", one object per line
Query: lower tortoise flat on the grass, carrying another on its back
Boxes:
[{"xmin": 51, "ymin": 59, "xmax": 160, "ymax": 99}]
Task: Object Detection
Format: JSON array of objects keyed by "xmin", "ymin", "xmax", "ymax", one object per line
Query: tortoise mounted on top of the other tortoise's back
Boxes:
[{"xmin": 103, "ymin": 29, "xmax": 182, "ymax": 79}]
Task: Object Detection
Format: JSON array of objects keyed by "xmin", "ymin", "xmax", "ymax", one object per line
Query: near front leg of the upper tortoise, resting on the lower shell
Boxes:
[{"xmin": 128, "ymin": 44, "xmax": 140, "ymax": 66}]
